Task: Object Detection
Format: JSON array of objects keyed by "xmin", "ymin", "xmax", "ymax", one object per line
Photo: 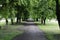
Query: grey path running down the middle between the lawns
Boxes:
[{"xmin": 12, "ymin": 22, "xmax": 47, "ymax": 40}]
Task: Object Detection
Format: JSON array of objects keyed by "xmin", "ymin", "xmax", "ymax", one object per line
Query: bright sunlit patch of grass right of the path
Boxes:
[{"xmin": 39, "ymin": 23, "xmax": 60, "ymax": 34}]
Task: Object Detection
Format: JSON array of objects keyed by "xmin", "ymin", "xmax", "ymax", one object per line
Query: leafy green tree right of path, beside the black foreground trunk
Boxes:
[{"xmin": 38, "ymin": 0, "xmax": 56, "ymax": 24}]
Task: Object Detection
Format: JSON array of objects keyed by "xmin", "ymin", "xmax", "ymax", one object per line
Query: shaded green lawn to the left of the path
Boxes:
[{"xmin": 0, "ymin": 25, "xmax": 23, "ymax": 40}]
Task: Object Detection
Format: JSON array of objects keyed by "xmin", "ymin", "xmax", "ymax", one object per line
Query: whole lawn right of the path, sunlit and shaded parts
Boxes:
[{"xmin": 39, "ymin": 22, "xmax": 60, "ymax": 40}]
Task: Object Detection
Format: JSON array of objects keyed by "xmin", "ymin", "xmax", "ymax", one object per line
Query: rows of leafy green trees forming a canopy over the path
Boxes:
[{"xmin": 0, "ymin": 0, "xmax": 57, "ymax": 24}]
